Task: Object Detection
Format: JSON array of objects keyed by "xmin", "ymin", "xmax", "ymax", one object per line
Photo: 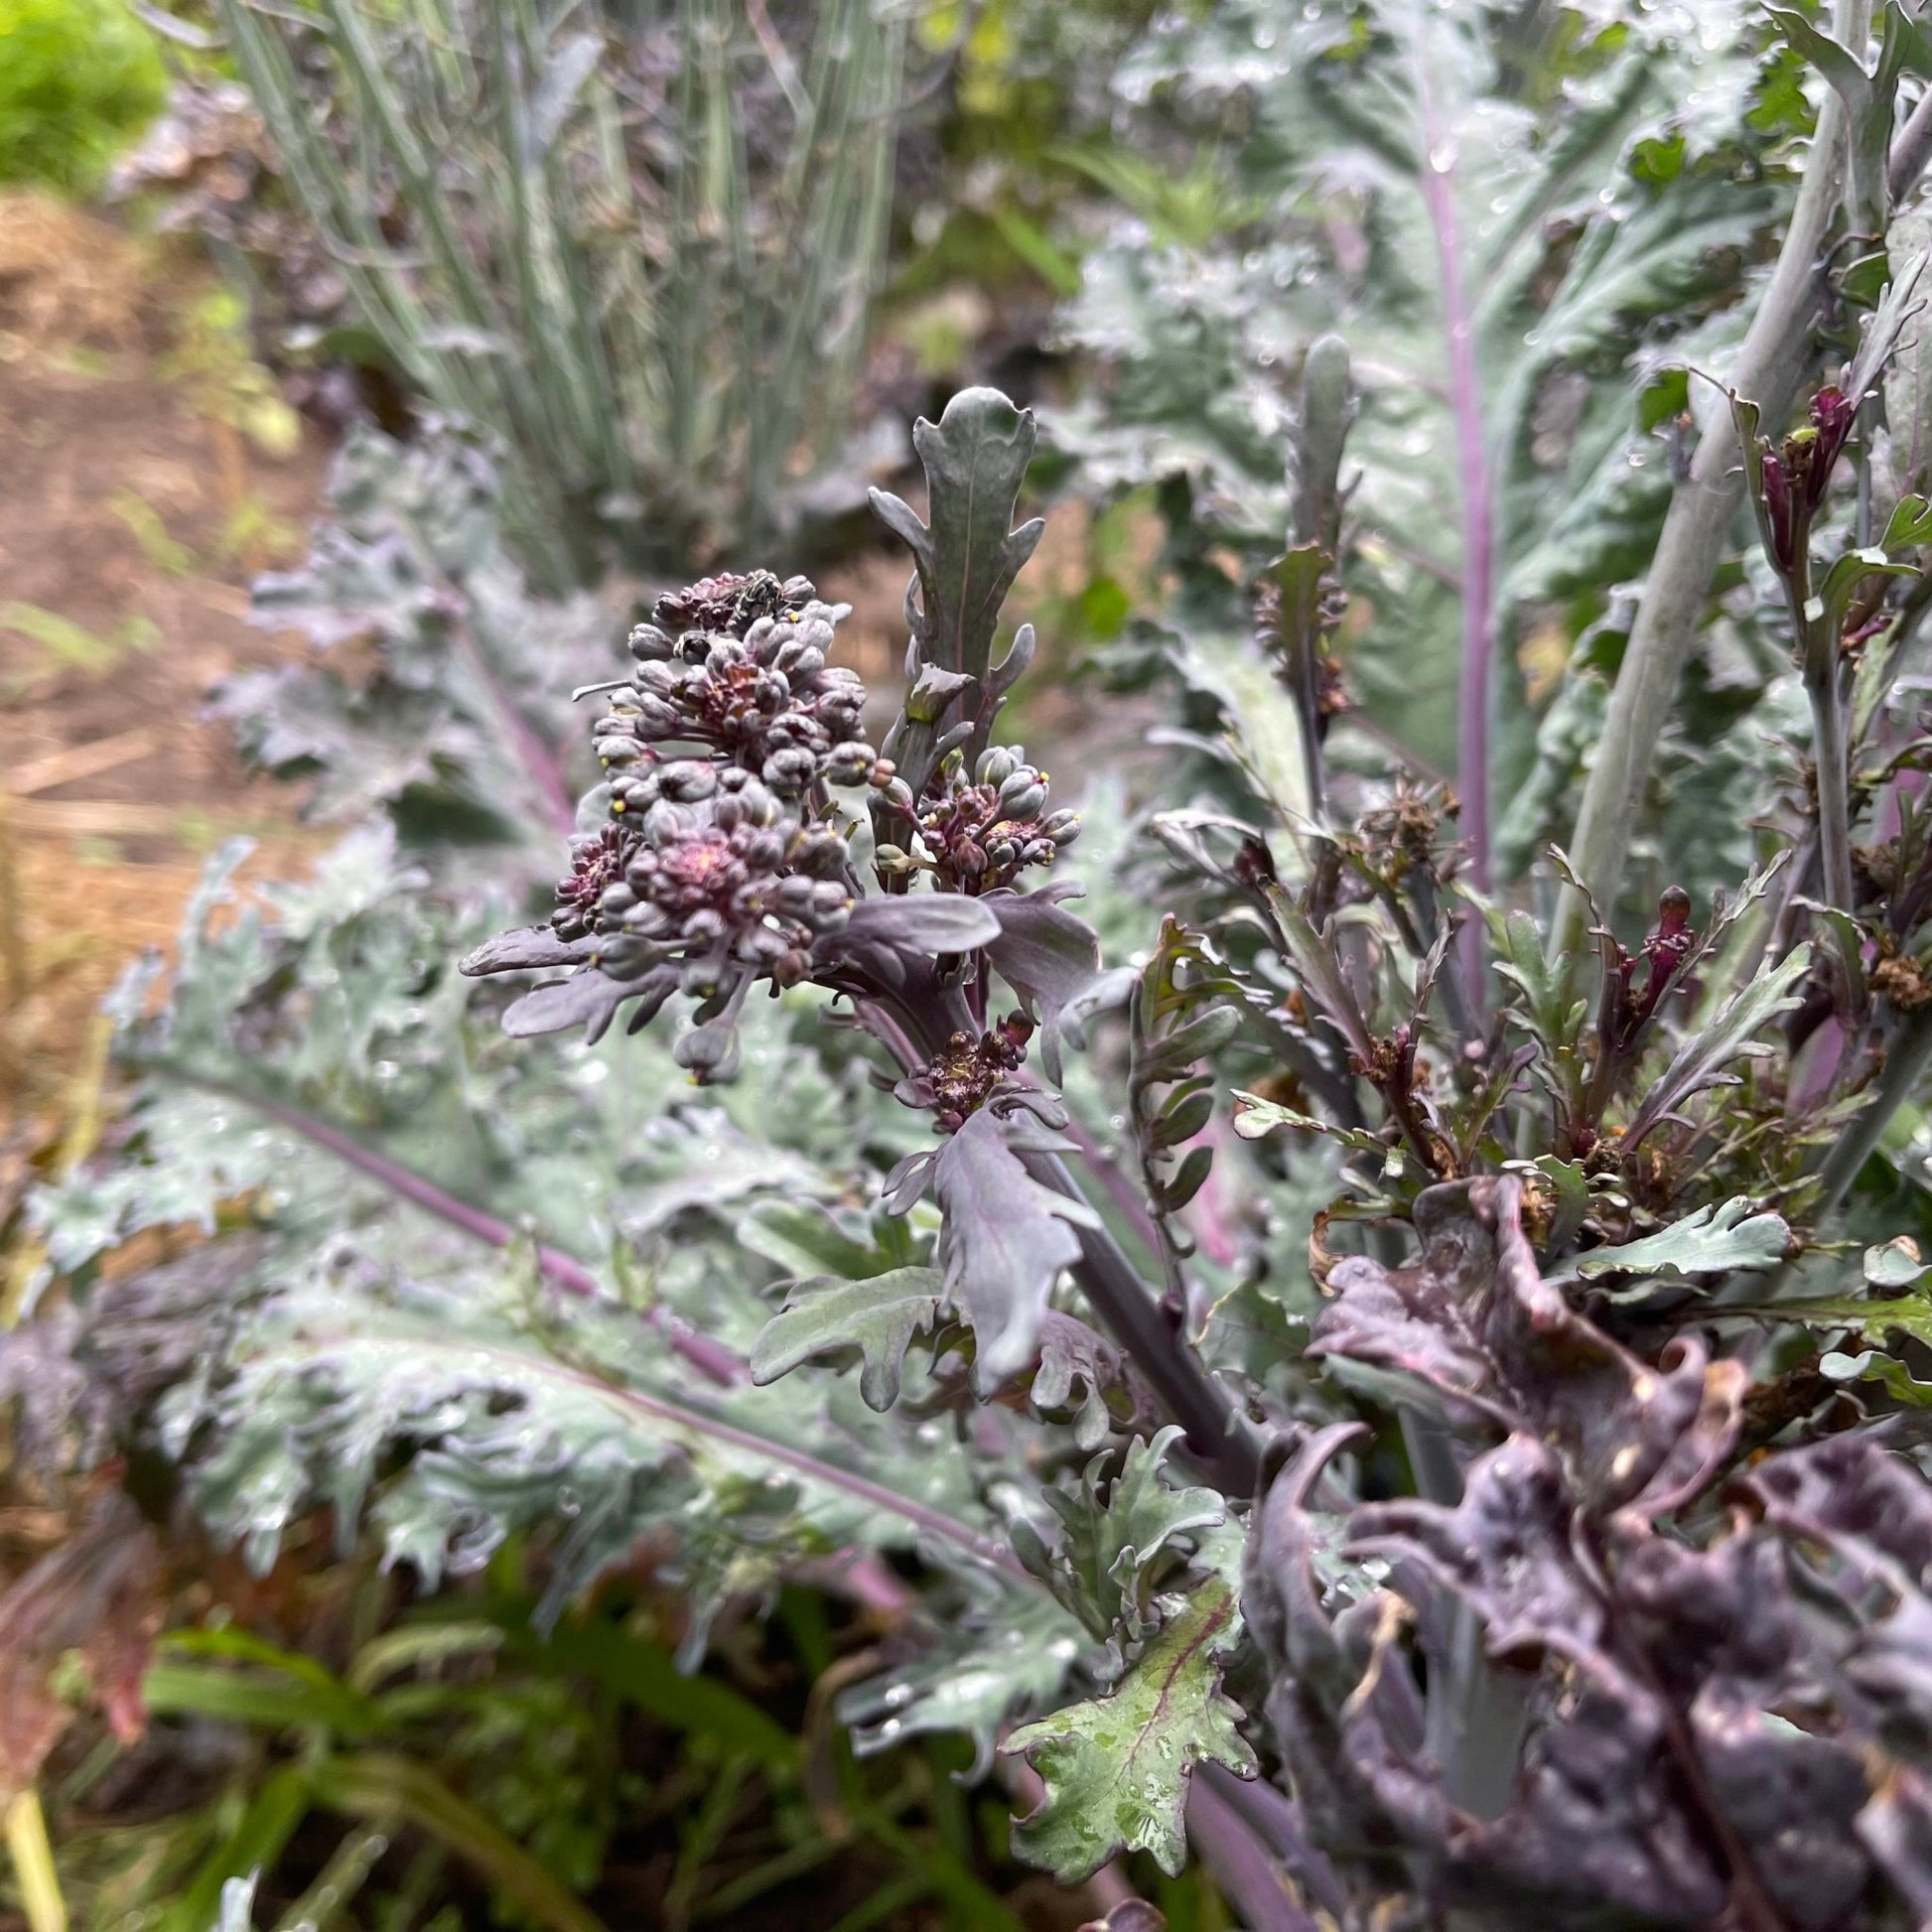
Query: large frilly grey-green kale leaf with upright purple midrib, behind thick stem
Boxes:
[{"xmin": 1045, "ymin": 0, "xmax": 1810, "ymax": 889}]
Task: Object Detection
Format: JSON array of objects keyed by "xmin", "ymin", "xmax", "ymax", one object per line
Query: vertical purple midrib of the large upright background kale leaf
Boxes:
[{"xmin": 1418, "ymin": 64, "xmax": 1495, "ymax": 1013}]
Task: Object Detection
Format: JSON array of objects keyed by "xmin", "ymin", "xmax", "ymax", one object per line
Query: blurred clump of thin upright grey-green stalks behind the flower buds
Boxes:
[{"xmin": 207, "ymin": 0, "xmax": 908, "ymax": 590}]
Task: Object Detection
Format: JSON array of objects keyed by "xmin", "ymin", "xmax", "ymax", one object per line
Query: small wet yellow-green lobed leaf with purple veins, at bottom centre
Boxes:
[{"xmin": 1007, "ymin": 1579, "xmax": 1256, "ymax": 1885}]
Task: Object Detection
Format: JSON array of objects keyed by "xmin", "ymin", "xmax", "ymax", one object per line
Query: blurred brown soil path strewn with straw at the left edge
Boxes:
[{"xmin": 0, "ymin": 196, "xmax": 329, "ymax": 1136}]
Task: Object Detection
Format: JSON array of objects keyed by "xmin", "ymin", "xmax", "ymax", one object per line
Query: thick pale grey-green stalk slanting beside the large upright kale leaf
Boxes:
[{"xmin": 1550, "ymin": 26, "xmax": 1870, "ymax": 968}]
